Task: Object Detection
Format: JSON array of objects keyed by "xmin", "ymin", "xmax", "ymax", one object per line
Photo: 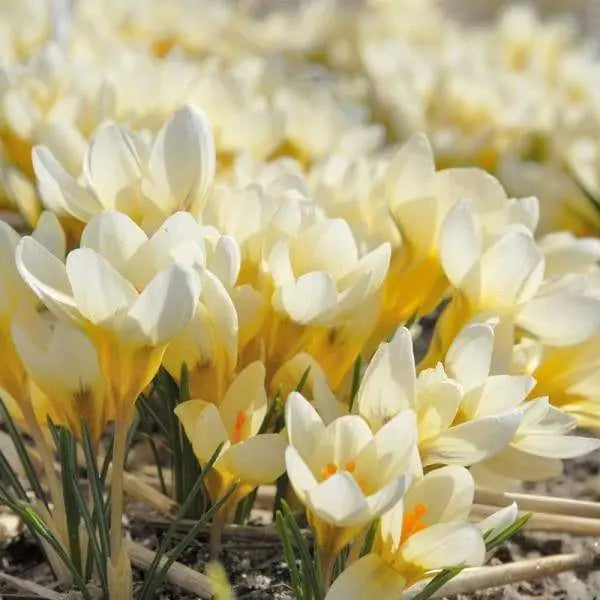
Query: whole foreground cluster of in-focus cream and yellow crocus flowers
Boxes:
[{"xmin": 0, "ymin": 73, "xmax": 600, "ymax": 598}]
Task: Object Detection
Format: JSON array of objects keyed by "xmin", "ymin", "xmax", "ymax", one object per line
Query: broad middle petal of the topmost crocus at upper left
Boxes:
[{"xmin": 84, "ymin": 124, "xmax": 142, "ymax": 212}]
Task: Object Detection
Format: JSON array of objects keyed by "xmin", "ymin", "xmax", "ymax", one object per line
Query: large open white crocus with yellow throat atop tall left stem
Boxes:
[{"xmin": 16, "ymin": 212, "xmax": 200, "ymax": 418}]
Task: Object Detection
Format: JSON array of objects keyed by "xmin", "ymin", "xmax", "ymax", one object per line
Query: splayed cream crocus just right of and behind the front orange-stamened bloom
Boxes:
[{"xmin": 356, "ymin": 327, "xmax": 521, "ymax": 466}]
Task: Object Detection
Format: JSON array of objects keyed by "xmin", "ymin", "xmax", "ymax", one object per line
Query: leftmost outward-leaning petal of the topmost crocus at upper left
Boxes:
[{"xmin": 31, "ymin": 146, "xmax": 104, "ymax": 222}]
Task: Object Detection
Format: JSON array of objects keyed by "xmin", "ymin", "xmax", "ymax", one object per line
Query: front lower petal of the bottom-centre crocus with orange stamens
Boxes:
[{"xmin": 306, "ymin": 471, "xmax": 371, "ymax": 527}]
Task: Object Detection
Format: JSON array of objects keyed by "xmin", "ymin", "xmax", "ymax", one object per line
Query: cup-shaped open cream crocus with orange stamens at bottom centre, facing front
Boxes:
[{"xmin": 285, "ymin": 392, "xmax": 416, "ymax": 556}]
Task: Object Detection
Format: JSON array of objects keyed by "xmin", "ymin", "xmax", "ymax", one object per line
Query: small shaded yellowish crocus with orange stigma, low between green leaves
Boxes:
[{"xmin": 175, "ymin": 362, "xmax": 286, "ymax": 506}]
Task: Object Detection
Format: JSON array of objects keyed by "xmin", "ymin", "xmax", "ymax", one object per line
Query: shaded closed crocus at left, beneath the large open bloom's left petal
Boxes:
[{"xmin": 12, "ymin": 308, "xmax": 106, "ymax": 443}]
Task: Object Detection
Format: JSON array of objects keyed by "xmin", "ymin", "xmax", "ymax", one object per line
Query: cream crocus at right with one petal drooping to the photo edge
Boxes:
[{"xmin": 424, "ymin": 201, "xmax": 600, "ymax": 372}]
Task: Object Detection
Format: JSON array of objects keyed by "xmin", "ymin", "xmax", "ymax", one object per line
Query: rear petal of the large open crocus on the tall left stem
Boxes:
[{"xmin": 81, "ymin": 211, "xmax": 148, "ymax": 274}]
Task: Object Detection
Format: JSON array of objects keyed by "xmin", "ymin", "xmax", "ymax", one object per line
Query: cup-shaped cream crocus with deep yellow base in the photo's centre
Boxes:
[{"xmin": 265, "ymin": 219, "xmax": 390, "ymax": 388}]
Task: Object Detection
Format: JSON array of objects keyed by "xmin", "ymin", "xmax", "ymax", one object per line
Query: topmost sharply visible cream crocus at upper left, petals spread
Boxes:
[{"xmin": 33, "ymin": 105, "xmax": 215, "ymax": 231}]
